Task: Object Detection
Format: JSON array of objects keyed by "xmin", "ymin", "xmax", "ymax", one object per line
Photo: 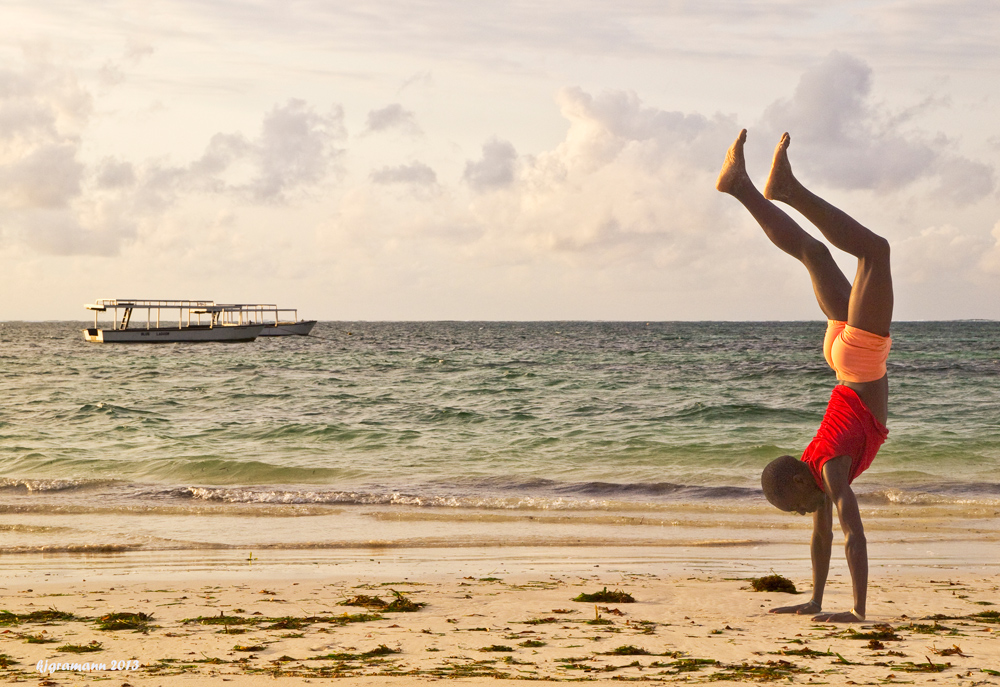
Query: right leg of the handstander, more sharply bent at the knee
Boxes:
[{"xmin": 764, "ymin": 133, "xmax": 893, "ymax": 336}]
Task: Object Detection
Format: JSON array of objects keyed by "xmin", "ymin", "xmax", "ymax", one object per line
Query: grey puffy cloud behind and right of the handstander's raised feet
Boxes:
[{"xmin": 764, "ymin": 52, "xmax": 995, "ymax": 204}]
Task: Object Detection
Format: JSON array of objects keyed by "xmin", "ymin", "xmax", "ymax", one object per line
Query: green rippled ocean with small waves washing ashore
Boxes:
[{"xmin": 0, "ymin": 321, "xmax": 1000, "ymax": 553}]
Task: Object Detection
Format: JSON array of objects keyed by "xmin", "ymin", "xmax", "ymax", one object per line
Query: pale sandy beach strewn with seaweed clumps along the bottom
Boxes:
[{"xmin": 0, "ymin": 543, "xmax": 1000, "ymax": 686}]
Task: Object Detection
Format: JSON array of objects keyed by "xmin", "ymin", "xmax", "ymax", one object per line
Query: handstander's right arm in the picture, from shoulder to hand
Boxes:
[{"xmin": 813, "ymin": 456, "xmax": 868, "ymax": 623}]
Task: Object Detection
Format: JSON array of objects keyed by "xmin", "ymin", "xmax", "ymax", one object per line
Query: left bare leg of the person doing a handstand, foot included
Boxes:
[{"xmin": 715, "ymin": 129, "xmax": 851, "ymax": 321}]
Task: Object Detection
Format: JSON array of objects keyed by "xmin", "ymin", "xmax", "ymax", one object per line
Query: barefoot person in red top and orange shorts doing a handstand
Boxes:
[{"xmin": 716, "ymin": 129, "xmax": 892, "ymax": 622}]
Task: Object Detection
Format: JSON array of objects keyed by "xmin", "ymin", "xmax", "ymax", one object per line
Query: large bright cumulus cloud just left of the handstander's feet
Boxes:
[{"xmin": 467, "ymin": 88, "xmax": 736, "ymax": 264}]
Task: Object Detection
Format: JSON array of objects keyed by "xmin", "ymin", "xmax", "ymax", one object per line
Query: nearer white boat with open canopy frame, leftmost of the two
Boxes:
[{"xmin": 83, "ymin": 298, "xmax": 264, "ymax": 343}]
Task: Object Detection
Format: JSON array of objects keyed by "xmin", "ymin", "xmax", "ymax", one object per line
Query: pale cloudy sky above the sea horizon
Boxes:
[{"xmin": 0, "ymin": 0, "xmax": 1000, "ymax": 321}]
